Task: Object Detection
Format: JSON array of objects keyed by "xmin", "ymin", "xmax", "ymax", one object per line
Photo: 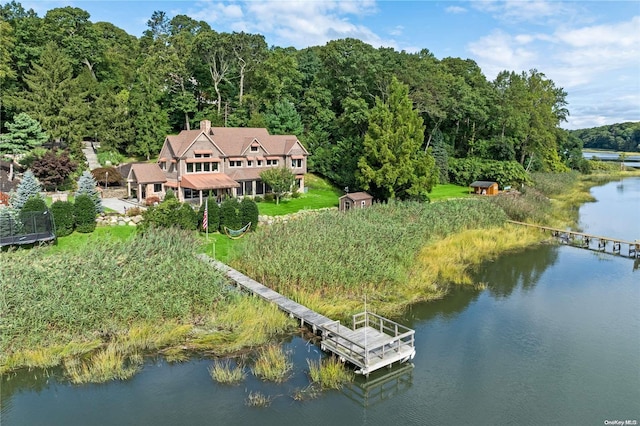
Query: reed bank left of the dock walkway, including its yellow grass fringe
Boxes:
[{"xmin": 0, "ymin": 229, "xmax": 295, "ymax": 376}]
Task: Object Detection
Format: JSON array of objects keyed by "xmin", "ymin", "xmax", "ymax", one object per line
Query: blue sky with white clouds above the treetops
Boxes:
[{"xmin": 21, "ymin": 0, "xmax": 640, "ymax": 129}]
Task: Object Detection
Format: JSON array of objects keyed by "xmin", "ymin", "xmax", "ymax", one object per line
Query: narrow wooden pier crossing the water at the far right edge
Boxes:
[{"xmin": 507, "ymin": 220, "xmax": 640, "ymax": 259}]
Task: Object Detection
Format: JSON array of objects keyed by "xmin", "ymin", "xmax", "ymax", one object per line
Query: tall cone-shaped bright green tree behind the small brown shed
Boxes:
[{"xmin": 357, "ymin": 77, "xmax": 438, "ymax": 200}]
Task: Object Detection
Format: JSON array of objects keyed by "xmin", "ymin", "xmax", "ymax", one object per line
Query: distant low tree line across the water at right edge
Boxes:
[{"xmin": 570, "ymin": 122, "xmax": 640, "ymax": 152}]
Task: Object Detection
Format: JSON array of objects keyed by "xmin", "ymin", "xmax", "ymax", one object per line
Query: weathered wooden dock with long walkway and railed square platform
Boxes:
[{"xmin": 199, "ymin": 254, "xmax": 416, "ymax": 376}]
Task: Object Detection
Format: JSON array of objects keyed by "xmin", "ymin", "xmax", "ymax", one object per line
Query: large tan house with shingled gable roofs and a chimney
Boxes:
[{"xmin": 127, "ymin": 120, "xmax": 309, "ymax": 203}]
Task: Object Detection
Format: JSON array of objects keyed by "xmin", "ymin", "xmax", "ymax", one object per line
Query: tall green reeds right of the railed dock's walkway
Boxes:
[{"xmin": 230, "ymin": 198, "xmax": 506, "ymax": 318}]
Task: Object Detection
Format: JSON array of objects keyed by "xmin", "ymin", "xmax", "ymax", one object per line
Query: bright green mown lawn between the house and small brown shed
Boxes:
[{"xmin": 258, "ymin": 174, "xmax": 342, "ymax": 216}]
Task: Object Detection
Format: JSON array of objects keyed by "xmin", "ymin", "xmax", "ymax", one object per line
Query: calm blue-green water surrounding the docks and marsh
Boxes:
[{"xmin": 0, "ymin": 179, "xmax": 640, "ymax": 426}]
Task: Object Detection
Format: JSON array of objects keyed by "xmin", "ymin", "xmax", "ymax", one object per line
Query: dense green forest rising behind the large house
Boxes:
[{"xmin": 0, "ymin": 1, "xmax": 582, "ymax": 197}]
